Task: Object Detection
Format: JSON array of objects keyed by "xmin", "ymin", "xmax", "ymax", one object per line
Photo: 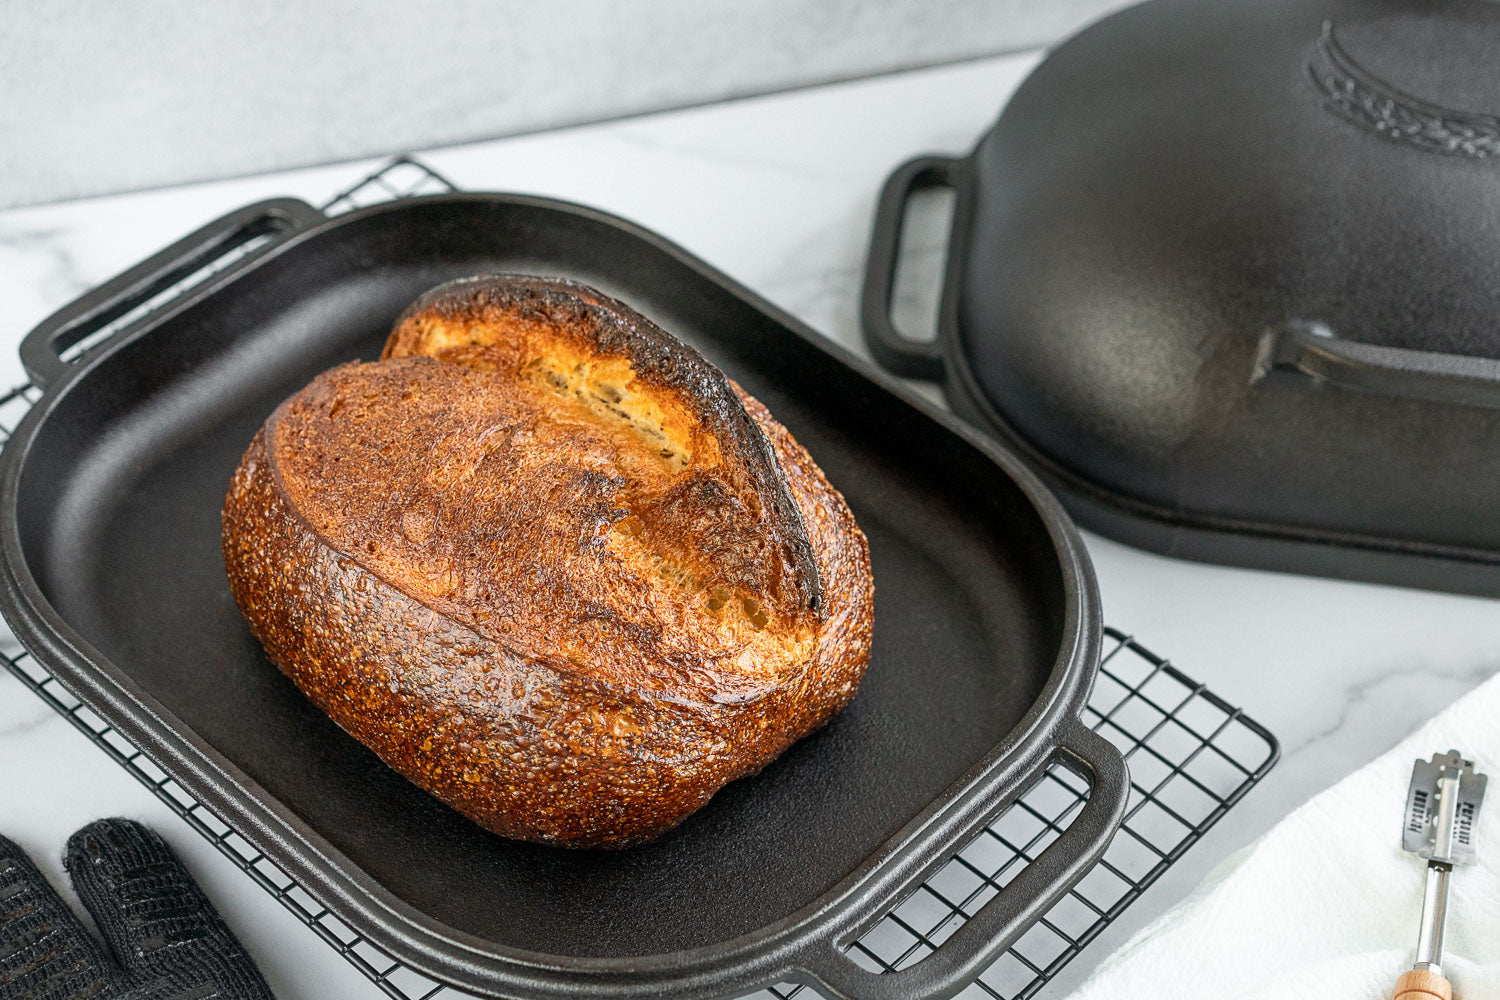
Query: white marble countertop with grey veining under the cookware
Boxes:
[{"xmin": 0, "ymin": 50, "xmax": 1500, "ymax": 1000}]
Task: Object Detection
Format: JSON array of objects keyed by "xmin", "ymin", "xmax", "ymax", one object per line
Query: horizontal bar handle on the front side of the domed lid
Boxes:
[{"xmin": 1271, "ymin": 322, "xmax": 1500, "ymax": 409}]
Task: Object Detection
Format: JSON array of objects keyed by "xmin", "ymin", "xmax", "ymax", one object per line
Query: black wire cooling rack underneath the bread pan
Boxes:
[{"xmin": 0, "ymin": 157, "xmax": 1280, "ymax": 1000}]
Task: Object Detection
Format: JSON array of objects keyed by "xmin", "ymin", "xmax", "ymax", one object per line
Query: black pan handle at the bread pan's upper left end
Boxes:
[{"xmin": 21, "ymin": 198, "xmax": 326, "ymax": 388}]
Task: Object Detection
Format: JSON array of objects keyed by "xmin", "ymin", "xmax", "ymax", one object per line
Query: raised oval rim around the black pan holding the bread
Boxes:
[{"xmin": 0, "ymin": 192, "xmax": 1101, "ymax": 997}]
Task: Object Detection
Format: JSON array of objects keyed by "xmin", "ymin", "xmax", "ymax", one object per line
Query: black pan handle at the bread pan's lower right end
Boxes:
[{"xmin": 803, "ymin": 720, "xmax": 1130, "ymax": 1000}]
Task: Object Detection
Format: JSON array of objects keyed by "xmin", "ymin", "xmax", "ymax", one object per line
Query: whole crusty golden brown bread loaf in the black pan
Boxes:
[{"xmin": 224, "ymin": 279, "xmax": 873, "ymax": 847}]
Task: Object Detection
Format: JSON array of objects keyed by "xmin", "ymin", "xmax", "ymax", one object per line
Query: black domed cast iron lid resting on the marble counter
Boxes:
[{"xmin": 864, "ymin": 0, "xmax": 1500, "ymax": 594}]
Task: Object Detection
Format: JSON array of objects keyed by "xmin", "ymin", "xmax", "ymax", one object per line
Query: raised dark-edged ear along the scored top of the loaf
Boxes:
[{"xmin": 381, "ymin": 274, "xmax": 819, "ymax": 616}]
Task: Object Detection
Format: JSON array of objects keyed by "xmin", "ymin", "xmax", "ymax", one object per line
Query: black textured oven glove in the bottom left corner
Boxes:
[{"xmin": 0, "ymin": 820, "xmax": 273, "ymax": 1000}]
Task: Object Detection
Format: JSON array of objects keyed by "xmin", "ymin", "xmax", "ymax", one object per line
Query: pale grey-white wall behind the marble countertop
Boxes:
[{"xmin": 0, "ymin": 0, "xmax": 1128, "ymax": 207}]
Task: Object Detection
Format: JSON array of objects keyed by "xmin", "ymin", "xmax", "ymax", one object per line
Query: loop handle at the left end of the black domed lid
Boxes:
[{"xmin": 860, "ymin": 156, "xmax": 962, "ymax": 382}]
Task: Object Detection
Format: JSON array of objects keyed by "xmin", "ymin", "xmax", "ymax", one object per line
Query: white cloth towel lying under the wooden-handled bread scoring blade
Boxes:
[{"xmin": 1074, "ymin": 676, "xmax": 1500, "ymax": 1000}]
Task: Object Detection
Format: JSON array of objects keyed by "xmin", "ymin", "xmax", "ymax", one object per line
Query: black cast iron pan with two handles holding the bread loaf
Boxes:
[{"xmin": 0, "ymin": 193, "xmax": 1128, "ymax": 1000}]
